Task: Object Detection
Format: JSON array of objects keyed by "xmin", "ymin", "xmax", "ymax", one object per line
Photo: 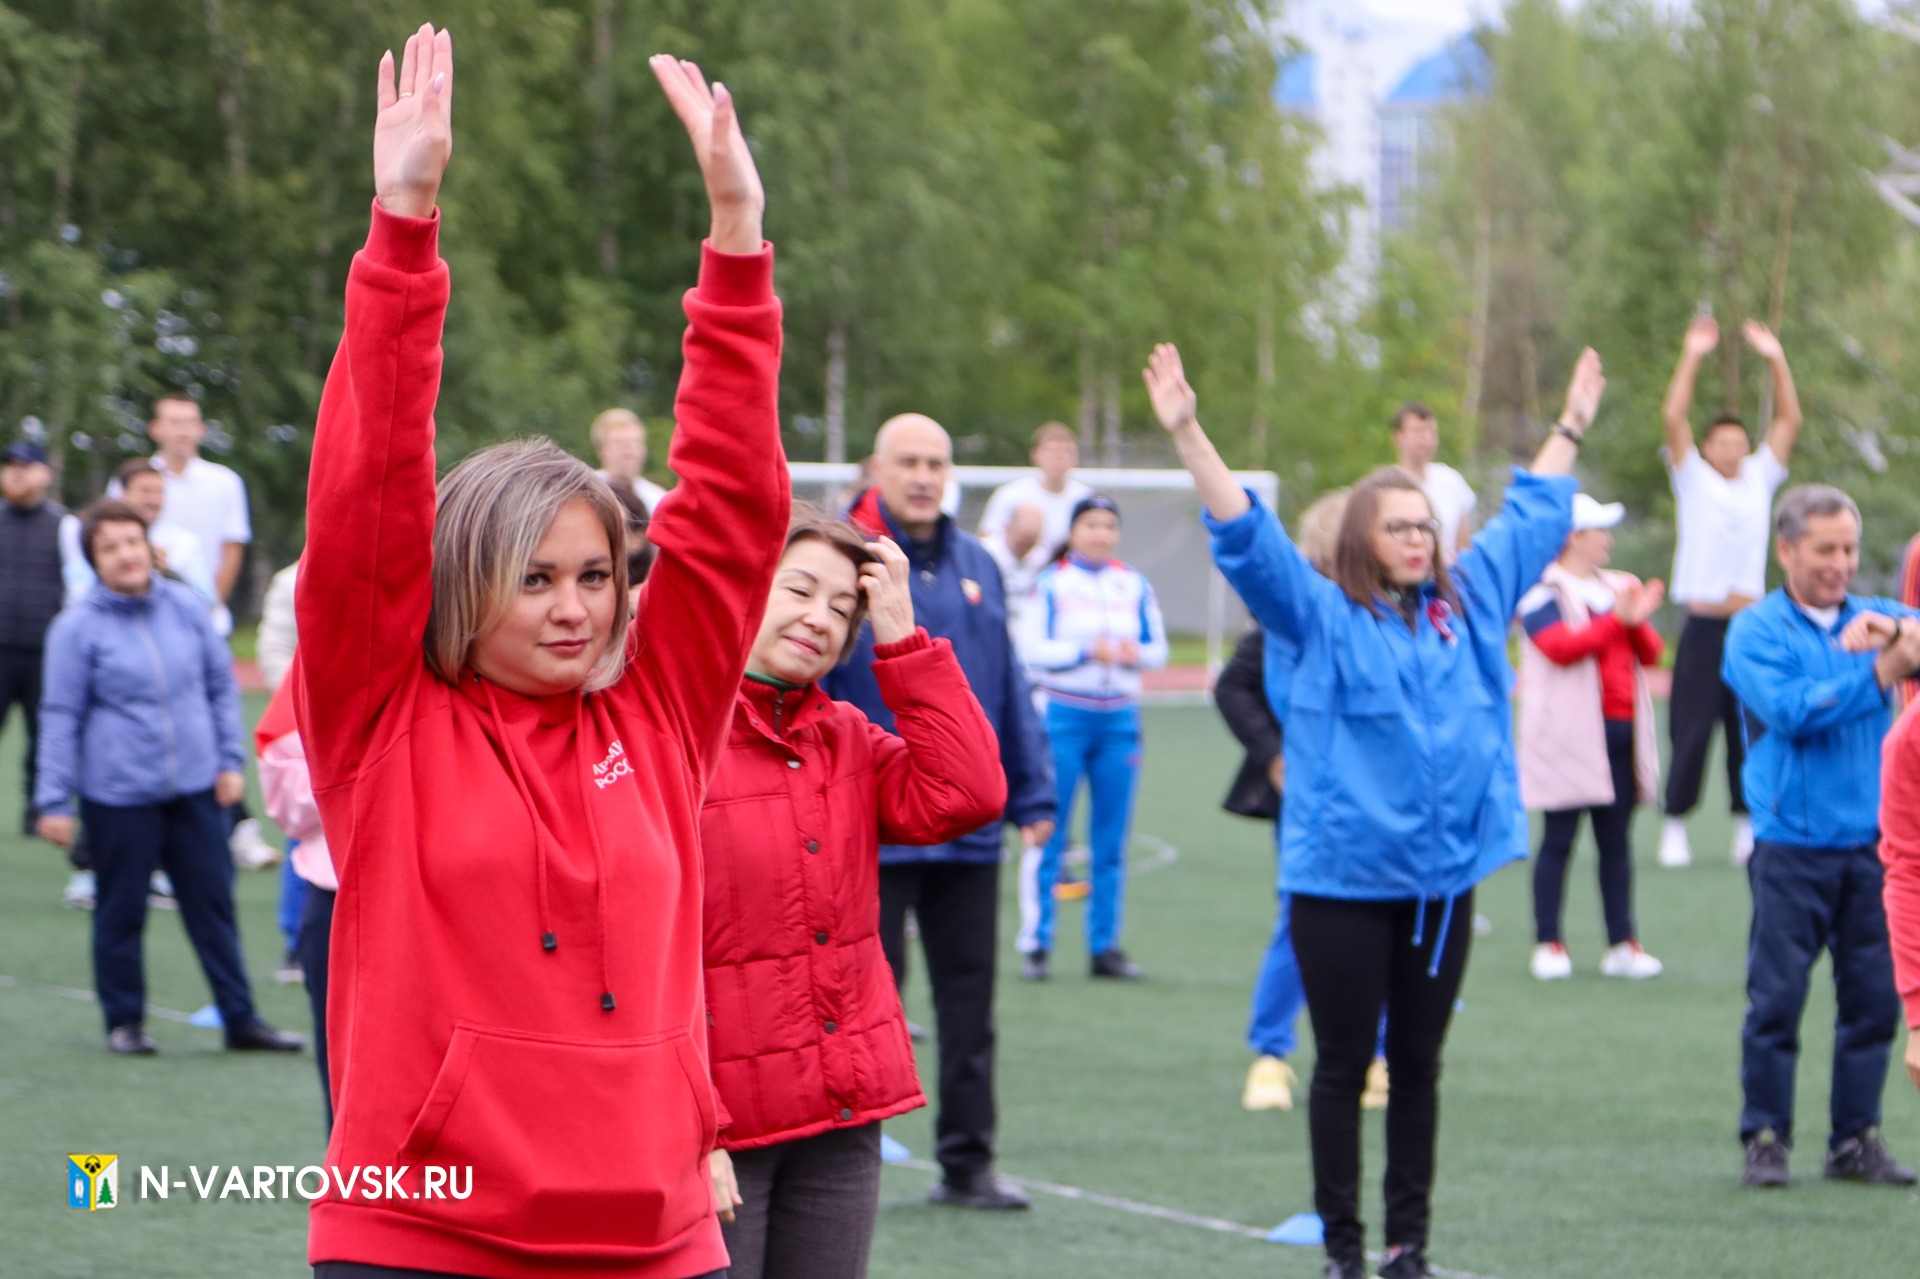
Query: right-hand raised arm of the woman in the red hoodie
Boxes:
[{"xmin": 628, "ymin": 56, "xmax": 791, "ymax": 778}]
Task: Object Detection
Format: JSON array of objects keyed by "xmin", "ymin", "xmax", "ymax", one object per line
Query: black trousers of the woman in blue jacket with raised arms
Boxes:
[{"xmin": 1292, "ymin": 891, "xmax": 1473, "ymax": 1264}]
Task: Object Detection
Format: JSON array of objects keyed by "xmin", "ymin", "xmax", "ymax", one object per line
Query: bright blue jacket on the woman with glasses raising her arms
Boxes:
[{"xmin": 1202, "ymin": 471, "xmax": 1576, "ymax": 903}]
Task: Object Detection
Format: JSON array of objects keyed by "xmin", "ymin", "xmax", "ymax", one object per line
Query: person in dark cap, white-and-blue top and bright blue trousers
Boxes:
[{"xmin": 1016, "ymin": 494, "xmax": 1167, "ymax": 981}]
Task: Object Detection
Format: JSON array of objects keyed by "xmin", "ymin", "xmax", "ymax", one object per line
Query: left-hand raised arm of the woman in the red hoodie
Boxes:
[{"xmin": 294, "ymin": 27, "xmax": 453, "ymax": 789}]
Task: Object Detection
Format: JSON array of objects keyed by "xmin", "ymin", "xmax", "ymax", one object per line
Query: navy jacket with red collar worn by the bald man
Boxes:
[{"xmin": 820, "ymin": 490, "xmax": 1058, "ymax": 866}]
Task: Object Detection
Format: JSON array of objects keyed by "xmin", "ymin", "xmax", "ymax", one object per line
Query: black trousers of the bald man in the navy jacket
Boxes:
[{"xmin": 879, "ymin": 862, "xmax": 1000, "ymax": 1181}]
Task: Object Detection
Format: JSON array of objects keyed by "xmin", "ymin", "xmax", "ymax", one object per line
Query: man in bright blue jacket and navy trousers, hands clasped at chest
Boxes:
[{"xmin": 1722, "ymin": 484, "xmax": 1920, "ymax": 1187}]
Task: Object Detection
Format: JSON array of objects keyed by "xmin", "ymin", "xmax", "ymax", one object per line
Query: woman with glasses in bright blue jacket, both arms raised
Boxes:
[{"xmin": 1144, "ymin": 346, "xmax": 1605, "ymax": 1279}]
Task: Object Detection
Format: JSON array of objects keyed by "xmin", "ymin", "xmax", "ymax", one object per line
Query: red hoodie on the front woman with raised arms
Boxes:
[{"xmin": 296, "ymin": 205, "xmax": 789, "ymax": 1279}]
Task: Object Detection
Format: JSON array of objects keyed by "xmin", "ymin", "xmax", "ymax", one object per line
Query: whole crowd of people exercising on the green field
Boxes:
[{"xmin": 0, "ymin": 27, "xmax": 1920, "ymax": 1279}]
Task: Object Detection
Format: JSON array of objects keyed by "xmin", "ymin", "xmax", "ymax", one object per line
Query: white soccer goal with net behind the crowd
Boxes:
[{"xmin": 787, "ymin": 463, "xmax": 1281, "ymax": 670}]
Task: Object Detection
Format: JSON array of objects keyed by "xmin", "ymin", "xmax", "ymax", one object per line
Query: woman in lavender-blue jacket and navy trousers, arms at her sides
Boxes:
[{"xmin": 35, "ymin": 501, "xmax": 303, "ymax": 1056}]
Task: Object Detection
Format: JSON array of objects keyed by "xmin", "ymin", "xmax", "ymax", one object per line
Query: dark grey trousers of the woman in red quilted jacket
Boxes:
[{"xmin": 720, "ymin": 1123, "xmax": 879, "ymax": 1279}]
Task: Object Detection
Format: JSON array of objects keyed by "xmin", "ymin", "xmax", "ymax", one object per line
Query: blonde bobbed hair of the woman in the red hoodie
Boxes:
[{"xmin": 426, "ymin": 438, "xmax": 630, "ymax": 693}]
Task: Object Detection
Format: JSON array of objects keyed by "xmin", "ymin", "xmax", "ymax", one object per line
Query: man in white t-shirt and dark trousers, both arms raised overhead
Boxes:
[{"xmin": 1661, "ymin": 315, "xmax": 1801, "ymax": 866}]
